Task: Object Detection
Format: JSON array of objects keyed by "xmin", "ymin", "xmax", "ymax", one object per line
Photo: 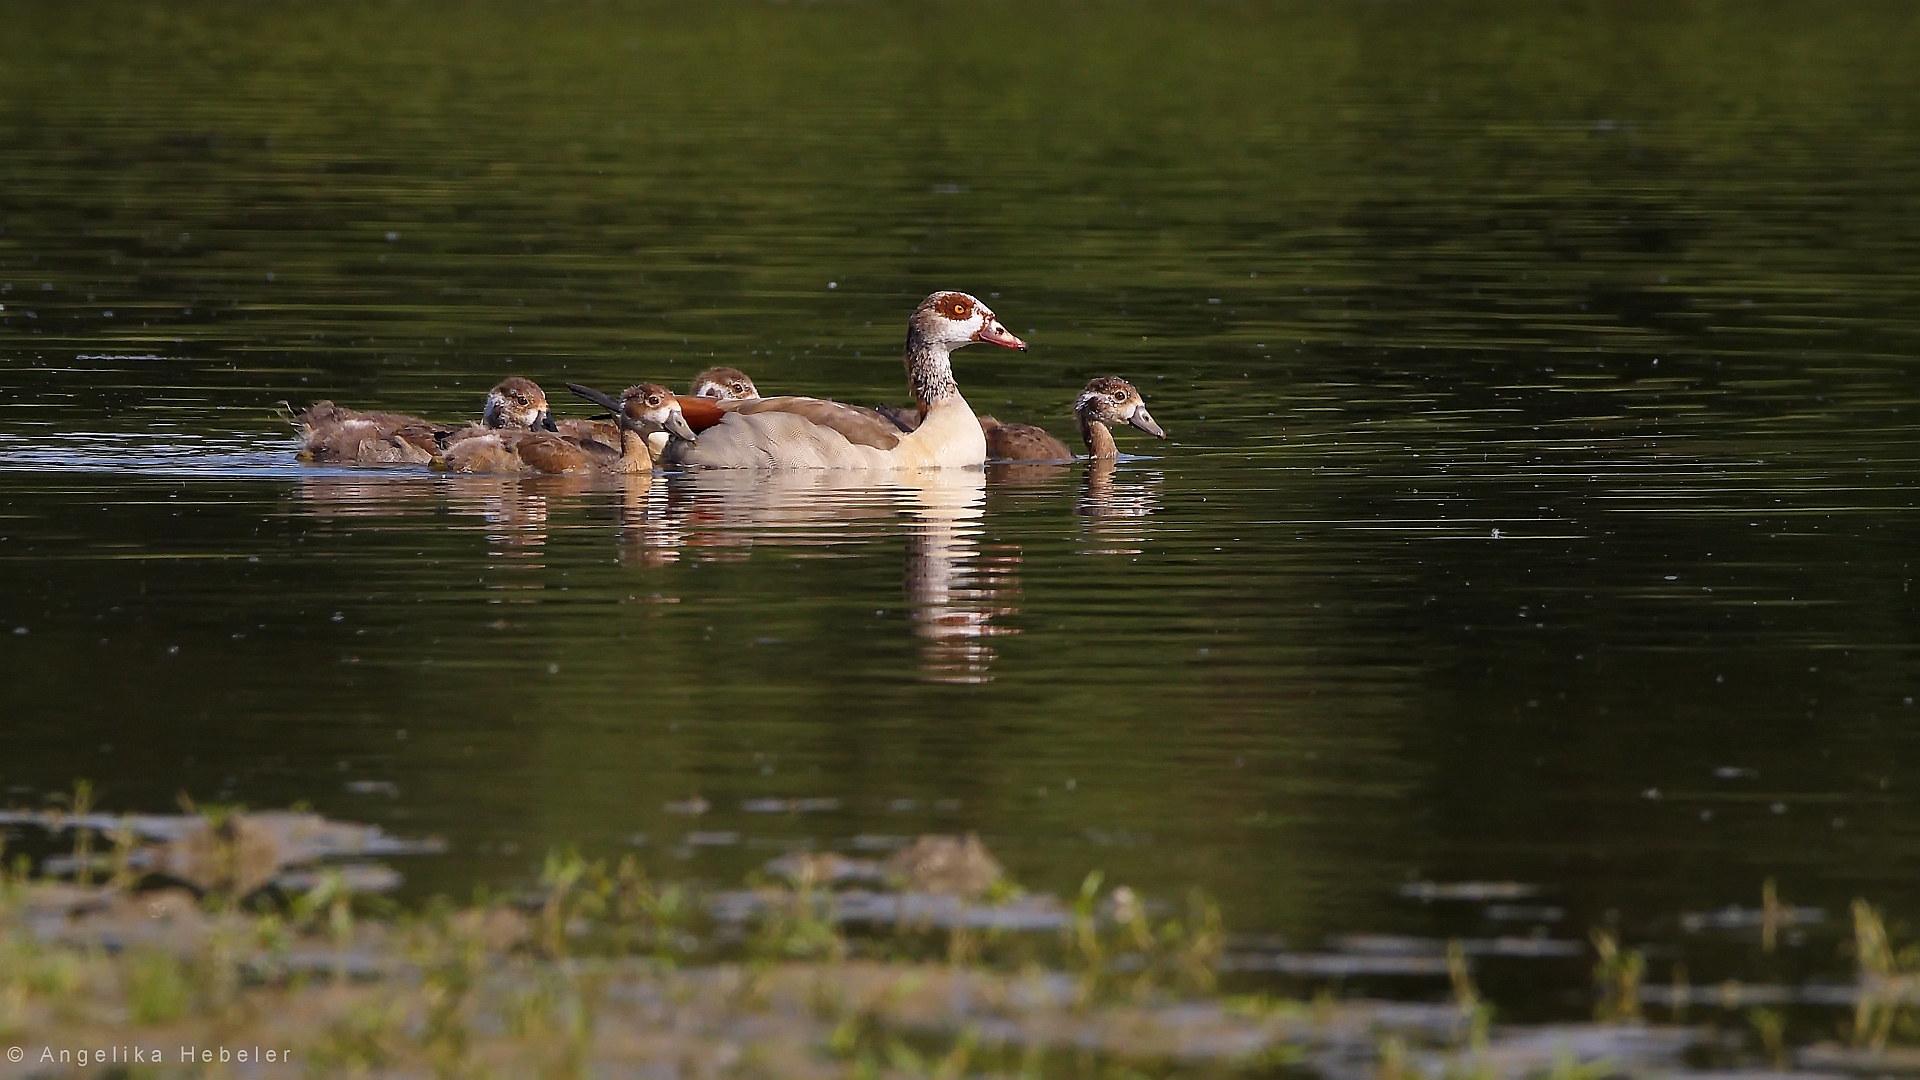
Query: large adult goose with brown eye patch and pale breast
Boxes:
[{"xmin": 666, "ymin": 292, "xmax": 1027, "ymax": 469}]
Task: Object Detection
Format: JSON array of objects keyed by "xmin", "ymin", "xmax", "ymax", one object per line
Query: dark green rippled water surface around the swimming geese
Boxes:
[{"xmin": 0, "ymin": 2, "xmax": 1920, "ymax": 1011}]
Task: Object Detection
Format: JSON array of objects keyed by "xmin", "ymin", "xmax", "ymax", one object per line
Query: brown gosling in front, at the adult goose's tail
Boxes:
[{"xmin": 445, "ymin": 382, "xmax": 695, "ymax": 473}]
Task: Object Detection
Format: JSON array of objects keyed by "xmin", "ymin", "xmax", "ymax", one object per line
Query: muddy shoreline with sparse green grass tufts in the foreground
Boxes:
[{"xmin": 0, "ymin": 799, "xmax": 1920, "ymax": 1080}]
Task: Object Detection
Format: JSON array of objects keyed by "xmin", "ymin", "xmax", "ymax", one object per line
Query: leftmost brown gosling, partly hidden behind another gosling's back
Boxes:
[{"xmin": 294, "ymin": 377, "xmax": 553, "ymax": 465}]
